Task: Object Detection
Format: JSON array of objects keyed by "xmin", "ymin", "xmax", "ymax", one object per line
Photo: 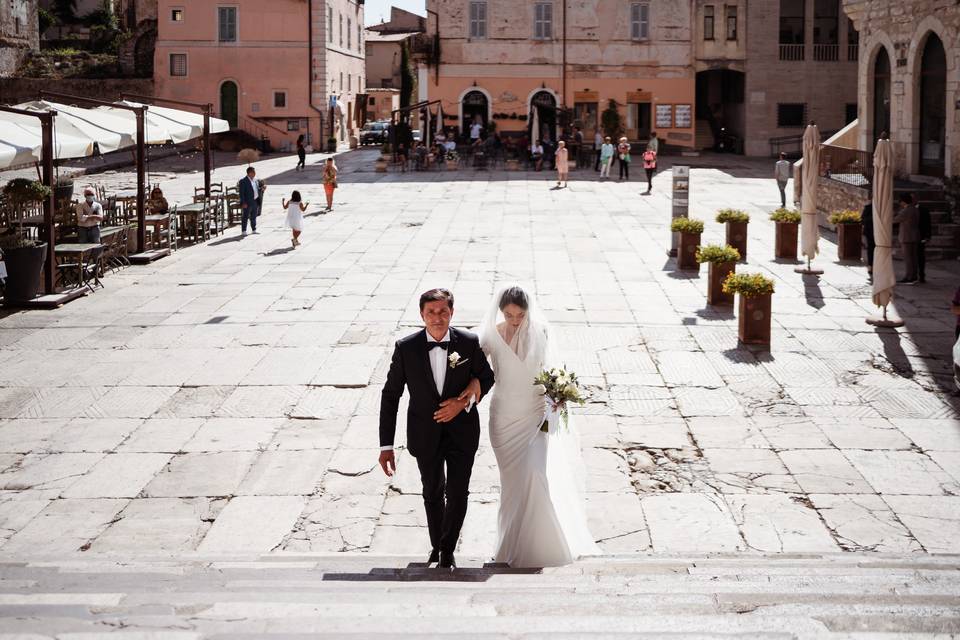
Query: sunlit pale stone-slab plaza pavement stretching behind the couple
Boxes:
[{"xmin": 0, "ymin": 151, "xmax": 960, "ymax": 558}]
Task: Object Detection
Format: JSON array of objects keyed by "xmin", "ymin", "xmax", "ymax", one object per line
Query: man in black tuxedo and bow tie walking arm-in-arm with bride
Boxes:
[{"xmin": 380, "ymin": 289, "xmax": 493, "ymax": 569}]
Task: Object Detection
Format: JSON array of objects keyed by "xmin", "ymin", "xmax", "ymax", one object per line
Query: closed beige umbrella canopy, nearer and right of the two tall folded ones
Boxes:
[{"xmin": 873, "ymin": 140, "xmax": 896, "ymax": 307}]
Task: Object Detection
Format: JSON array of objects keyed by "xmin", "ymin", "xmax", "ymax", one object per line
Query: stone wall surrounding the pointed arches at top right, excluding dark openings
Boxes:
[{"xmin": 843, "ymin": 0, "xmax": 960, "ymax": 176}]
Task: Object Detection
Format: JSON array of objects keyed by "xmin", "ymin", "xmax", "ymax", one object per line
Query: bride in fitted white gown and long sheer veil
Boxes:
[{"xmin": 480, "ymin": 286, "xmax": 599, "ymax": 567}]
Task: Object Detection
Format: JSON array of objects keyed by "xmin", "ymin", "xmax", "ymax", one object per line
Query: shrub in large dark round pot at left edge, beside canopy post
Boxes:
[{"xmin": 0, "ymin": 178, "xmax": 53, "ymax": 303}]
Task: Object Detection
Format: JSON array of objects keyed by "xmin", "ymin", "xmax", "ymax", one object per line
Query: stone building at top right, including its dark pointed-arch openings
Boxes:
[{"xmin": 843, "ymin": 0, "xmax": 960, "ymax": 176}]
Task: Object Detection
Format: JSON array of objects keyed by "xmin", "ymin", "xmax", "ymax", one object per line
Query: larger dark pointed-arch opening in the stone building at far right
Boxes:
[{"xmin": 919, "ymin": 33, "xmax": 947, "ymax": 176}]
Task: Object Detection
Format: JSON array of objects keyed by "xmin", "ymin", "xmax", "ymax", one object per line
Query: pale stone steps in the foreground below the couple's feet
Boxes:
[{"xmin": 0, "ymin": 553, "xmax": 960, "ymax": 640}]
